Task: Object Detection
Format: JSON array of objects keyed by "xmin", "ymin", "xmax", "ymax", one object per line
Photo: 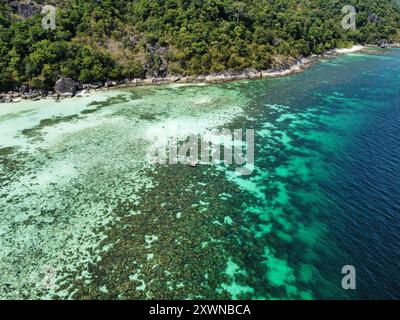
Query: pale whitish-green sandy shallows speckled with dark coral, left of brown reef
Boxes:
[{"xmin": 0, "ymin": 86, "xmax": 245, "ymax": 299}]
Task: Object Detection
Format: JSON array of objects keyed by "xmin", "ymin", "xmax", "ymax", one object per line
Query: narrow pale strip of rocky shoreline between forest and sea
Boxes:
[{"xmin": 0, "ymin": 44, "xmax": 388, "ymax": 104}]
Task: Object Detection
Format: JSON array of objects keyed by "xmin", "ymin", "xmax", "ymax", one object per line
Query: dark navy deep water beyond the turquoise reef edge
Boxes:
[{"xmin": 322, "ymin": 50, "xmax": 400, "ymax": 299}]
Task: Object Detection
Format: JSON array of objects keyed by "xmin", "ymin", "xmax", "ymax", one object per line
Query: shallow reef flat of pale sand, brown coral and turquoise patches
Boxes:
[{"xmin": 0, "ymin": 81, "xmax": 344, "ymax": 299}]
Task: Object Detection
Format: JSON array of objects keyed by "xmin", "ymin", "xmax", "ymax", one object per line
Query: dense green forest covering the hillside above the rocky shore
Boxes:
[{"xmin": 0, "ymin": 0, "xmax": 400, "ymax": 91}]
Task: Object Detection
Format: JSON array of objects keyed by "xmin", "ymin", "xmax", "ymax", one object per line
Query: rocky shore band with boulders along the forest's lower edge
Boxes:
[{"xmin": 0, "ymin": 43, "xmax": 400, "ymax": 103}]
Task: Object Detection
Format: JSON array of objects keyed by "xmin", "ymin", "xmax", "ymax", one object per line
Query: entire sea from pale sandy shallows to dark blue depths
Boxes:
[{"xmin": 0, "ymin": 50, "xmax": 400, "ymax": 299}]
